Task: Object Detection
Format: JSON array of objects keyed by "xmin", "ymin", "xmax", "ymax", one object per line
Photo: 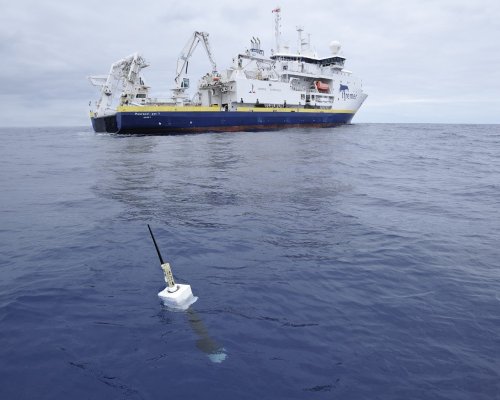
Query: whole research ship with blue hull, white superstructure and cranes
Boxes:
[{"xmin": 89, "ymin": 8, "xmax": 367, "ymax": 134}]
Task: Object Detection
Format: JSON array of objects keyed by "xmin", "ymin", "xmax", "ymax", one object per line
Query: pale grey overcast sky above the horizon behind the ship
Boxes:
[{"xmin": 0, "ymin": 0, "xmax": 500, "ymax": 126}]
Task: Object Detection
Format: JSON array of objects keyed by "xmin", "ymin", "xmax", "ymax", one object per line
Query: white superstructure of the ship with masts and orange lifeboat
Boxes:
[{"xmin": 191, "ymin": 9, "xmax": 366, "ymax": 110}]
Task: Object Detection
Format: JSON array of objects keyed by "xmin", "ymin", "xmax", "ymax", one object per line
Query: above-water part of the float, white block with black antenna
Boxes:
[{"xmin": 148, "ymin": 224, "xmax": 198, "ymax": 310}]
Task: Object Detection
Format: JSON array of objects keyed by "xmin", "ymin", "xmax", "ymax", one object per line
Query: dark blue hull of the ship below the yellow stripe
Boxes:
[{"xmin": 91, "ymin": 110, "xmax": 354, "ymax": 135}]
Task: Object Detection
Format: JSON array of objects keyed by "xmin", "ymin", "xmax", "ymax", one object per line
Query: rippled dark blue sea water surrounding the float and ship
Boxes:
[{"xmin": 0, "ymin": 124, "xmax": 500, "ymax": 400}]
